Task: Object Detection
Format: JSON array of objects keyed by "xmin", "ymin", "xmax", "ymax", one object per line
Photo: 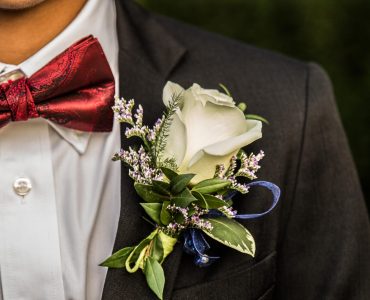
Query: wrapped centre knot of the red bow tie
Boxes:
[{"xmin": 0, "ymin": 78, "xmax": 40, "ymax": 121}]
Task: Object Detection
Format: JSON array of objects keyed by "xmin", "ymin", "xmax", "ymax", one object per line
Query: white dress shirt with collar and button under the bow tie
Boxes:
[{"xmin": 0, "ymin": 0, "xmax": 120, "ymax": 300}]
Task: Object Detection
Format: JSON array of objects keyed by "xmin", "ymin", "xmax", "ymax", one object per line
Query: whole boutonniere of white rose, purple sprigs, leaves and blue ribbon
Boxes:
[{"xmin": 101, "ymin": 82, "xmax": 280, "ymax": 299}]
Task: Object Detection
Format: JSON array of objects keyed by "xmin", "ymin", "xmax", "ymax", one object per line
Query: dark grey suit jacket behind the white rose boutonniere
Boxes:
[{"xmin": 103, "ymin": 0, "xmax": 370, "ymax": 300}]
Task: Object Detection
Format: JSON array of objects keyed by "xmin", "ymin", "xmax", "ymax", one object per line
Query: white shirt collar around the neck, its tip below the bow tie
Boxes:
[{"xmin": 0, "ymin": 0, "xmax": 118, "ymax": 154}]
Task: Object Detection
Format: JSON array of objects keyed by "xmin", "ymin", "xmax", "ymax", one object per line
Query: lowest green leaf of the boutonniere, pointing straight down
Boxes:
[{"xmin": 144, "ymin": 256, "xmax": 165, "ymax": 300}]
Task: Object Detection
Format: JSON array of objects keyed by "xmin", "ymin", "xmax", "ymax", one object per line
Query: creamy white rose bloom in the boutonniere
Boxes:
[{"xmin": 163, "ymin": 81, "xmax": 262, "ymax": 183}]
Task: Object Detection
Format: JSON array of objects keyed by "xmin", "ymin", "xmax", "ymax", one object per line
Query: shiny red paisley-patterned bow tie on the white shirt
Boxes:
[{"xmin": 0, "ymin": 36, "xmax": 115, "ymax": 131}]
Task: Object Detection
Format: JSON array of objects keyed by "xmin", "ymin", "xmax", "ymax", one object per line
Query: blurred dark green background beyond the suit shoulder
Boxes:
[{"xmin": 138, "ymin": 0, "xmax": 370, "ymax": 208}]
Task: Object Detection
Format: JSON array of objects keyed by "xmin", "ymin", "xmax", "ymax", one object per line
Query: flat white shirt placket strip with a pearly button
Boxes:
[{"xmin": 0, "ymin": 119, "xmax": 68, "ymax": 300}]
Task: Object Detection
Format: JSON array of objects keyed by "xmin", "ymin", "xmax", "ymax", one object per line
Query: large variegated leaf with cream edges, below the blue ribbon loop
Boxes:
[{"xmin": 203, "ymin": 218, "xmax": 256, "ymax": 257}]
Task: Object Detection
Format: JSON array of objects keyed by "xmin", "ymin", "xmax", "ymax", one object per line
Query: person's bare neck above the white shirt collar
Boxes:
[{"xmin": 0, "ymin": 0, "xmax": 87, "ymax": 65}]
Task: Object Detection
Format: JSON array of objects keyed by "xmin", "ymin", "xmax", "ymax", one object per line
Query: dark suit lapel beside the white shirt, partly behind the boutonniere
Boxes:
[{"xmin": 103, "ymin": 0, "xmax": 186, "ymax": 300}]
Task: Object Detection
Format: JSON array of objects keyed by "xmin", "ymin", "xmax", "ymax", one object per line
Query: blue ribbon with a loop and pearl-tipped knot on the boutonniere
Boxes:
[{"xmin": 184, "ymin": 181, "xmax": 280, "ymax": 267}]
